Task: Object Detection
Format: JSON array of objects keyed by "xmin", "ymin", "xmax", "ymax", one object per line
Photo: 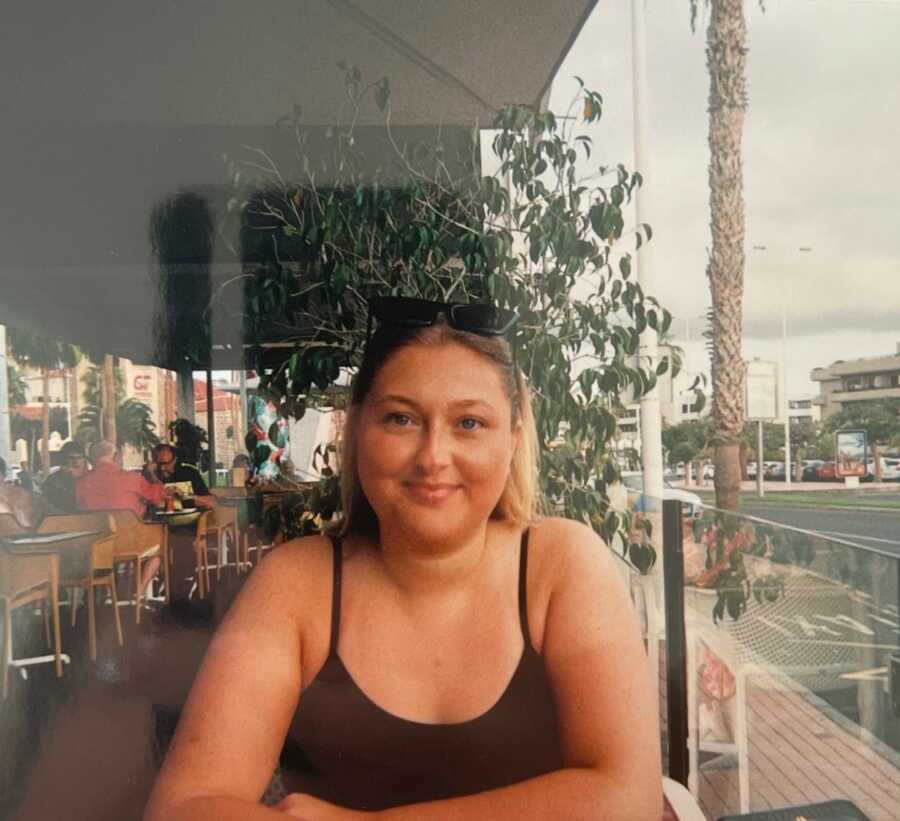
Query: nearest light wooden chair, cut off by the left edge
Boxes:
[{"xmin": 0, "ymin": 513, "xmax": 62, "ymax": 700}]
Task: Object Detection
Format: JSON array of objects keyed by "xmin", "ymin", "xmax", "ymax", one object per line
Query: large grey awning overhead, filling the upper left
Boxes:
[{"xmin": 0, "ymin": 0, "xmax": 596, "ymax": 367}]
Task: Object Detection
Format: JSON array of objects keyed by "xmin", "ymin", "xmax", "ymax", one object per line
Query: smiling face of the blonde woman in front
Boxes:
[{"xmin": 356, "ymin": 343, "xmax": 520, "ymax": 543}]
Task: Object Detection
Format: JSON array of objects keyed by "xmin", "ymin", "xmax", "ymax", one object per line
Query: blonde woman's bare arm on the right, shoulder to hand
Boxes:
[{"xmin": 282, "ymin": 520, "xmax": 662, "ymax": 821}]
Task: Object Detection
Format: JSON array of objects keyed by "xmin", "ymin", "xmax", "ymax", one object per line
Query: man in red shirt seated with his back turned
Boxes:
[{"xmin": 75, "ymin": 442, "xmax": 166, "ymax": 587}]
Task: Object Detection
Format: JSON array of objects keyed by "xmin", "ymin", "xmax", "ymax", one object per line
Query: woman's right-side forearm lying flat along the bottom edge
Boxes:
[{"xmin": 375, "ymin": 768, "xmax": 663, "ymax": 821}]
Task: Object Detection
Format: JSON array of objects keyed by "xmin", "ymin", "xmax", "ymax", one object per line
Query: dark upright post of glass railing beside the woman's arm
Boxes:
[{"xmin": 663, "ymin": 499, "xmax": 689, "ymax": 787}]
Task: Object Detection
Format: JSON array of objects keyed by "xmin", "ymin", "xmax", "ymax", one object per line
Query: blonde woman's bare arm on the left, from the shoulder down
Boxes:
[{"xmin": 144, "ymin": 540, "xmax": 331, "ymax": 821}]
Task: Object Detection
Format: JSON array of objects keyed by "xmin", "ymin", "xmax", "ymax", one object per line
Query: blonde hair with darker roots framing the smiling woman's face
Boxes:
[{"xmin": 336, "ymin": 321, "xmax": 540, "ymax": 536}]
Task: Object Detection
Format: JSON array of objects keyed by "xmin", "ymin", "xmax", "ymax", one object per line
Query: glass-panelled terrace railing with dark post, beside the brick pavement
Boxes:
[{"xmin": 614, "ymin": 490, "xmax": 900, "ymax": 819}]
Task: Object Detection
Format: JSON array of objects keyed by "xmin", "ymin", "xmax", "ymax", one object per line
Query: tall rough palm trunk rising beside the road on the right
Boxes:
[{"xmin": 706, "ymin": 0, "xmax": 747, "ymax": 510}]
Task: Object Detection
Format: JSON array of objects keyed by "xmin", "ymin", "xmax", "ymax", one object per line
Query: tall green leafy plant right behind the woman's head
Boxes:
[{"xmin": 223, "ymin": 65, "xmax": 671, "ymax": 552}]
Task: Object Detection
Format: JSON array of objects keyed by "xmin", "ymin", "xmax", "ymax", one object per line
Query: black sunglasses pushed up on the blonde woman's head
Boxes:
[{"xmin": 366, "ymin": 296, "xmax": 519, "ymax": 338}]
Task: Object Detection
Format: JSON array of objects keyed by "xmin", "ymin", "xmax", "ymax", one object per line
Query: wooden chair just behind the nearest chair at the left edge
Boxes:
[{"xmin": 38, "ymin": 512, "xmax": 124, "ymax": 660}]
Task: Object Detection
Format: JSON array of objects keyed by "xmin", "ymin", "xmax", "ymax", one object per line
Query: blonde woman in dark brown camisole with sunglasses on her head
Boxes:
[{"xmin": 146, "ymin": 299, "xmax": 662, "ymax": 821}]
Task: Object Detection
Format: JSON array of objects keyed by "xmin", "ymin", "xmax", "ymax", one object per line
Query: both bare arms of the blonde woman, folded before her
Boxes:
[{"xmin": 145, "ymin": 522, "xmax": 662, "ymax": 821}]
